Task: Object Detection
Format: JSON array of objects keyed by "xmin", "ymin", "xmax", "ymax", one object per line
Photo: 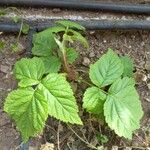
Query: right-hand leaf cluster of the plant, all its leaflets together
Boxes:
[{"xmin": 83, "ymin": 49, "xmax": 143, "ymax": 139}]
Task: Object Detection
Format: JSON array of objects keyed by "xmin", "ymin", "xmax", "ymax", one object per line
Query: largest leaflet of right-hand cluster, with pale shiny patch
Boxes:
[{"xmin": 104, "ymin": 77, "xmax": 143, "ymax": 139}]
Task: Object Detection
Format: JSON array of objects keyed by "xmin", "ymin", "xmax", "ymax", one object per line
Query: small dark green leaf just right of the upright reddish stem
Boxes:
[{"xmin": 66, "ymin": 48, "xmax": 78, "ymax": 64}]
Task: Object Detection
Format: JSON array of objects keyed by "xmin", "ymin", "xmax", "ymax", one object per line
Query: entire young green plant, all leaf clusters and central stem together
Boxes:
[{"xmin": 4, "ymin": 21, "xmax": 143, "ymax": 142}]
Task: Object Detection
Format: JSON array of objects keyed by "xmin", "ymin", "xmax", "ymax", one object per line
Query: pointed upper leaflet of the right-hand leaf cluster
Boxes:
[{"xmin": 89, "ymin": 49, "xmax": 123, "ymax": 87}]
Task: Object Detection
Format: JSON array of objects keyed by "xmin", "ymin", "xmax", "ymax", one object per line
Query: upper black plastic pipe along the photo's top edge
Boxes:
[{"xmin": 0, "ymin": 0, "xmax": 150, "ymax": 14}]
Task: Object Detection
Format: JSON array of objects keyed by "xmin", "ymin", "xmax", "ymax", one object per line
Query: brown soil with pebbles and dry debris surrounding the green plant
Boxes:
[{"xmin": 0, "ymin": 0, "xmax": 150, "ymax": 150}]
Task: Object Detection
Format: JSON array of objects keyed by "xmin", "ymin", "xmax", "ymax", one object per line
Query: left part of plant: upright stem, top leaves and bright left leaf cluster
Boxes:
[{"xmin": 4, "ymin": 21, "xmax": 88, "ymax": 142}]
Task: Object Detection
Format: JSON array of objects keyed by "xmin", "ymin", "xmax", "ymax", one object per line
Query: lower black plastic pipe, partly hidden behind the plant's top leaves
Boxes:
[{"xmin": 0, "ymin": 20, "xmax": 150, "ymax": 33}]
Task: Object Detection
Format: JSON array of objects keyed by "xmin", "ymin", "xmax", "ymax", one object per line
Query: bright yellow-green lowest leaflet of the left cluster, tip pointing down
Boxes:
[{"xmin": 4, "ymin": 88, "xmax": 48, "ymax": 142}]
